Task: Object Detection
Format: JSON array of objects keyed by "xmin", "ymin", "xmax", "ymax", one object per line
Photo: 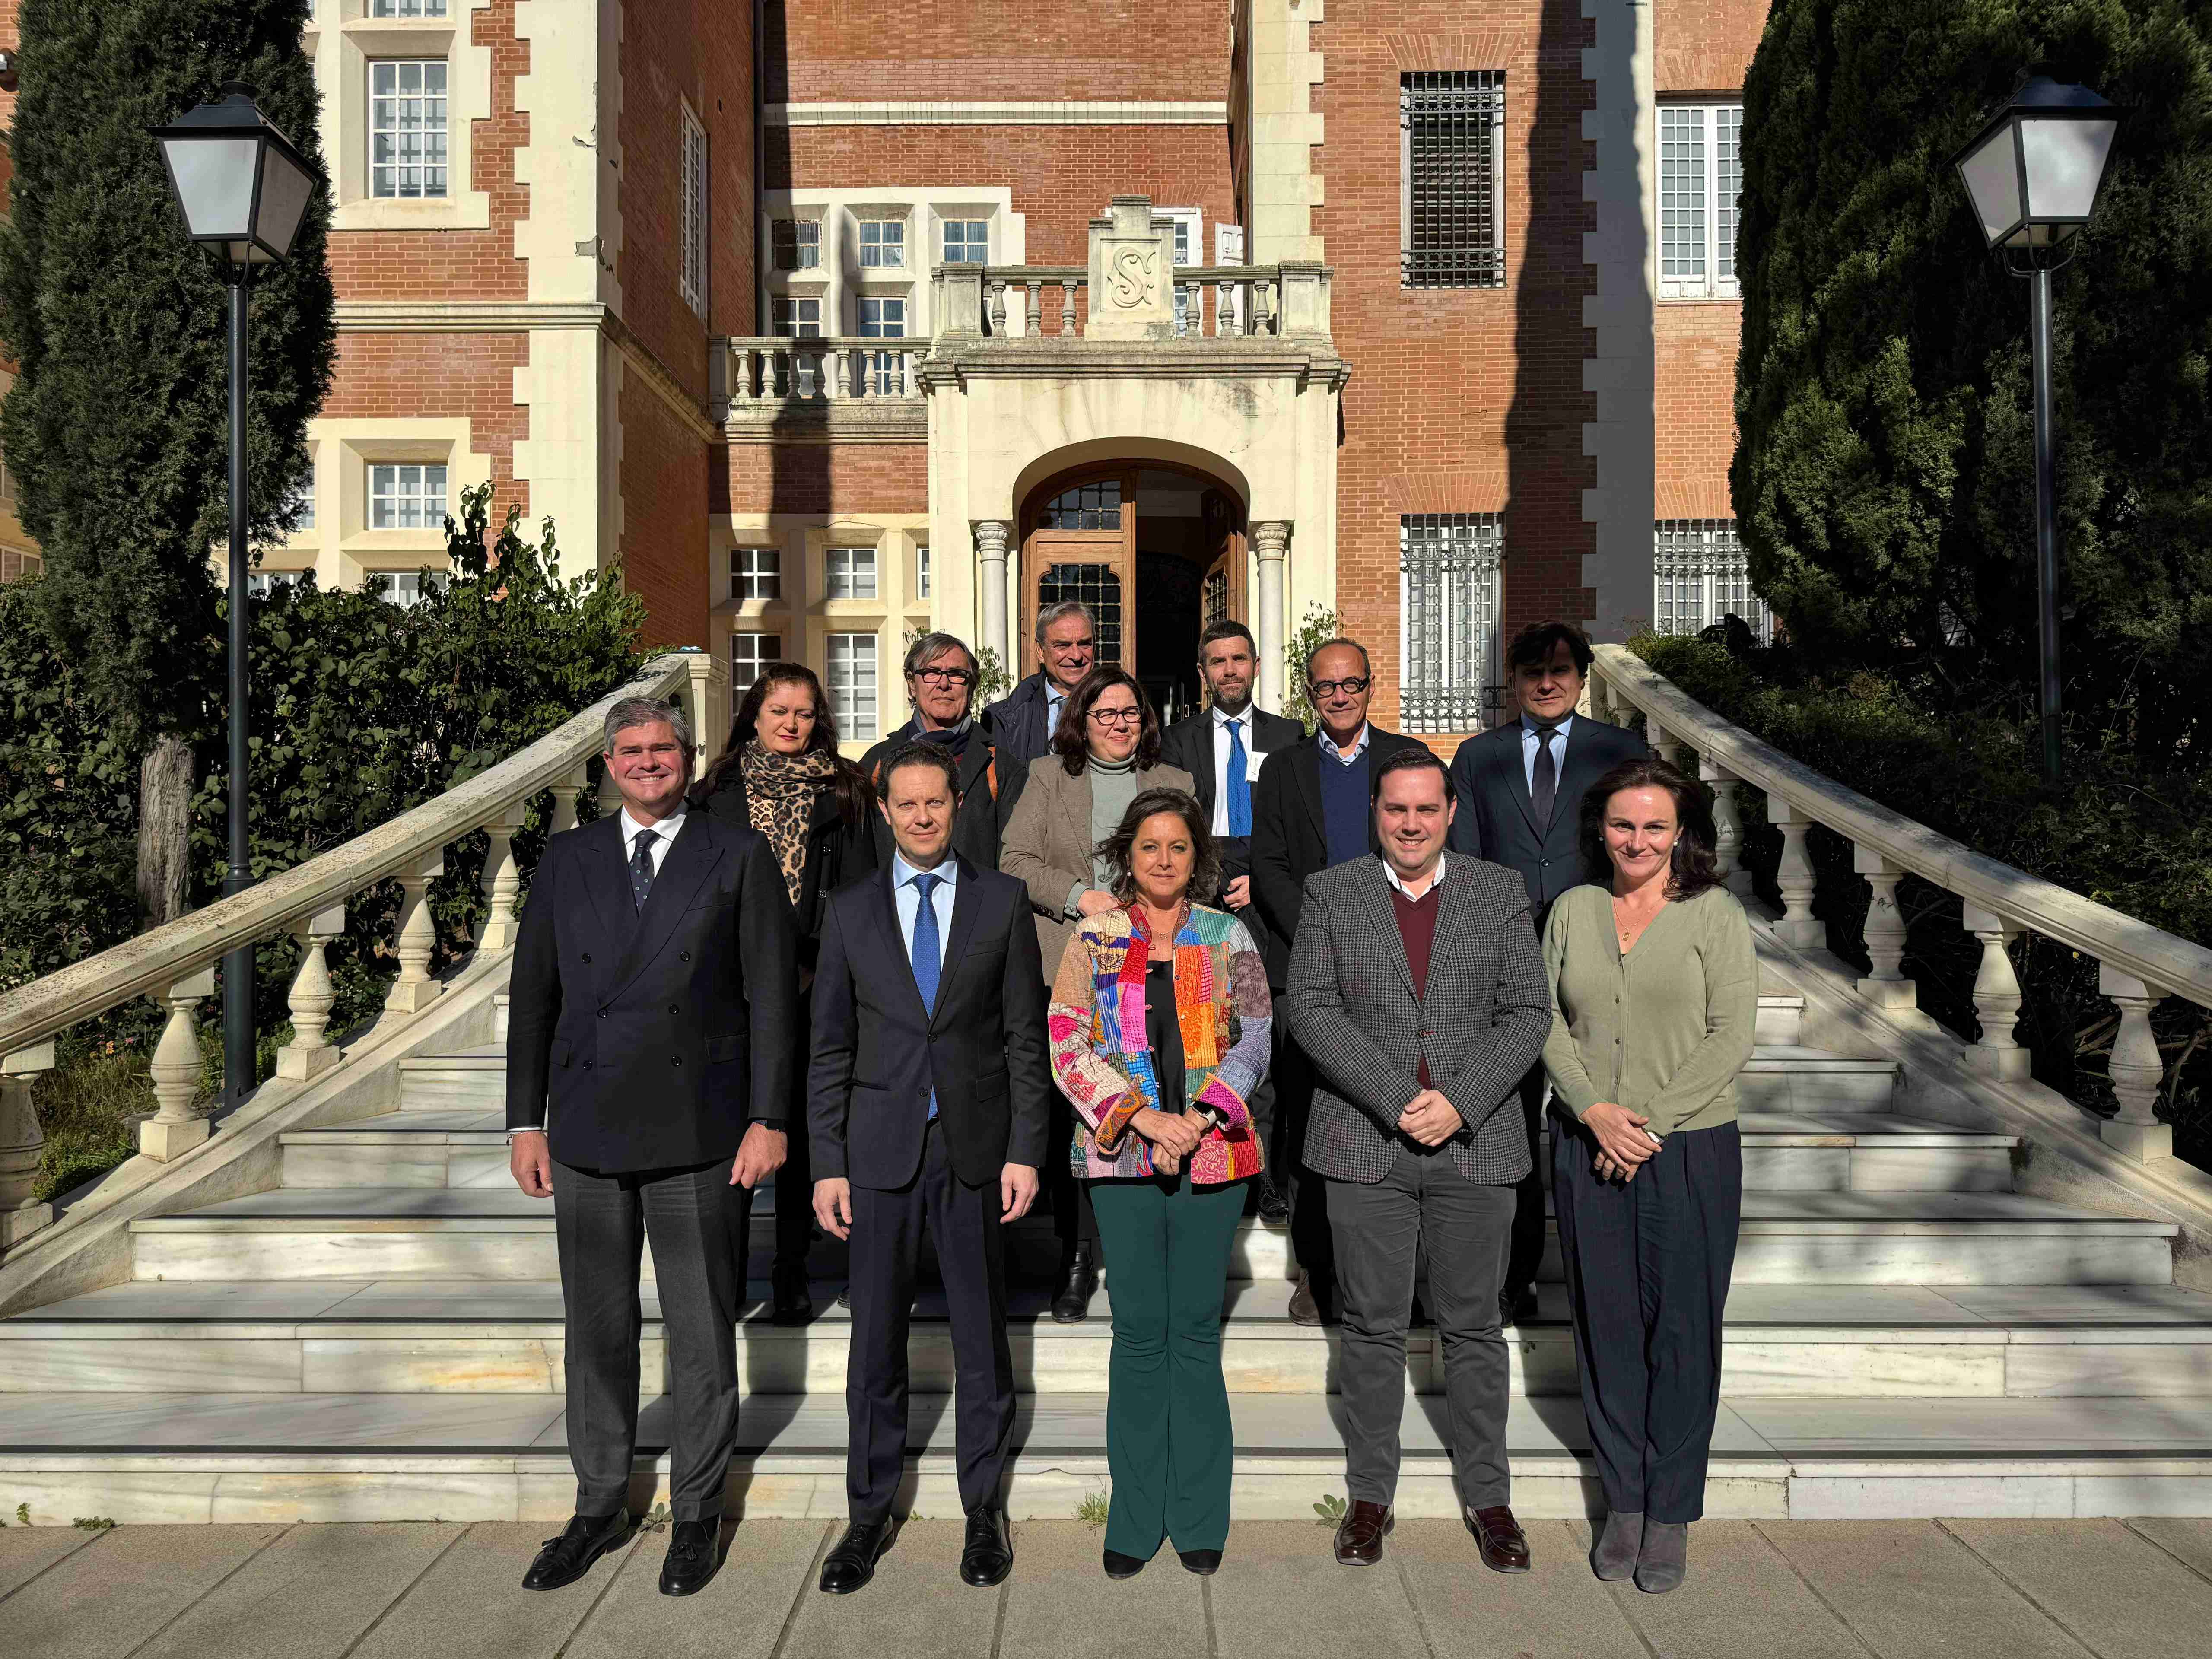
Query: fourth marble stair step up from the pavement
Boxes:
[{"xmin": 279, "ymin": 1110, "xmax": 2020, "ymax": 1192}]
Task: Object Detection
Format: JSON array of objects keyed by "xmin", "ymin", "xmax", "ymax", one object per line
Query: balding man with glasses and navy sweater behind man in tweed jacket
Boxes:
[{"xmin": 1252, "ymin": 639, "xmax": 1422, "ymax": 1325}]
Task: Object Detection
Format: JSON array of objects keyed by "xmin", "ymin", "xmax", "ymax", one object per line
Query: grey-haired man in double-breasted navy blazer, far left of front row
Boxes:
[{"xmin": 506, "ymin": 697, "xmax": 798, "ymax": 1595}]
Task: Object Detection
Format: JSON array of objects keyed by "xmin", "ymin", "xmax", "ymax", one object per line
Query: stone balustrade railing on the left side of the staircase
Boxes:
[{"xmin": 0, "ymin": 650, "xmax": 725, "ymax": 1250}]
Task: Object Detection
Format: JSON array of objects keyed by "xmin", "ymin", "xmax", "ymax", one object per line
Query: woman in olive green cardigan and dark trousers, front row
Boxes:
[{"xmin": 1544, "ymin": 759, "xmax": 1758, "ymax": 1592}]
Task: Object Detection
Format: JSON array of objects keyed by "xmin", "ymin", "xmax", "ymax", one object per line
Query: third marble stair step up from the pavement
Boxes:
[{"xmin": 130, "ymin": 1185, "xmax": 2177, "ymax": 1285}]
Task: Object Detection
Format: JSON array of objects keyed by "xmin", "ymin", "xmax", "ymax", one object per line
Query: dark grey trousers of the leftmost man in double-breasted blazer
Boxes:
[{"xmin": 553, "ymin": 1159, "xmax": 752, "ymax": 1519}]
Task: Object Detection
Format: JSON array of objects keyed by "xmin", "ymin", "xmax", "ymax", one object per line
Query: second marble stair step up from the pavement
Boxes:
[{"xmin": 0, "ymin": 1278, "xmax": 2212, "ymax": 1398}]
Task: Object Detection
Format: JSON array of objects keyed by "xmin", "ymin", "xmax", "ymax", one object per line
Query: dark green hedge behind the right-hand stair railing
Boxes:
[{"xmin": 1628, "ymin": 635, "xmax": 2212, "ymax": 1163}]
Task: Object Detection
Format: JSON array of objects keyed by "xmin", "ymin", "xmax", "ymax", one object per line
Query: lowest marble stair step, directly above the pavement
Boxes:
[{"xmin": 0, "ymin": 1391, "xmax": 2212, "ymax": 1531}]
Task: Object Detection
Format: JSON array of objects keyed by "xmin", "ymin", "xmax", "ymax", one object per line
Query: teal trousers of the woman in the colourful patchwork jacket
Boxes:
[{"xmin": 1090, "ymin": 1175, "xmax": 1246, "ymax": 1562}]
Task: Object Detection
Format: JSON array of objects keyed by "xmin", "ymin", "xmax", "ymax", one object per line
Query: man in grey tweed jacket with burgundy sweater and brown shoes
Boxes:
[{"xmin": 1287, "ymin": 748, "xmax": 1551, "ymax": 1573}]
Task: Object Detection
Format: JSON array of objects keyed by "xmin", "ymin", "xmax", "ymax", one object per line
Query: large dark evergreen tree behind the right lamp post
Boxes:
[{"xmin": 1732, "ymin": 0, "xmax": 2212, "ymax": 766}]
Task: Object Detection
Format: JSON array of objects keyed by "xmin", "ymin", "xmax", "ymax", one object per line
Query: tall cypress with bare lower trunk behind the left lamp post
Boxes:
[{"xmin": 0, "ymin": 0, "xmax": 336, "ymax": 922}]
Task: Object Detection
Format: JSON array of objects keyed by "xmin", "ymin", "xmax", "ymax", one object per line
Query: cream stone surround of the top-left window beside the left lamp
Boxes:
[{"xmin": 301, "ymin": 0, "xmax": 491, "ymax": 230}]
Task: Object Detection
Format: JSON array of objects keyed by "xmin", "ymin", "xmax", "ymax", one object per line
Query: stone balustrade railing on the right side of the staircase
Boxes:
[{"xmin": 1590, "ymin": 646, "xmax": 2212, "ymax": 1163}]
